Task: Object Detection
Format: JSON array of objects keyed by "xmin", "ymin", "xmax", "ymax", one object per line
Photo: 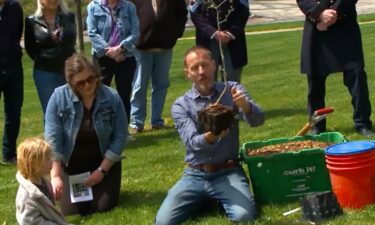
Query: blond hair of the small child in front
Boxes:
[{"xmin": 17, "ymin": 138, "xmax": 52, "ymax": 180}]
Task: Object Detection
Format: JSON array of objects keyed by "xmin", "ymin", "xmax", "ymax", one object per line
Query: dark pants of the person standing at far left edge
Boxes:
[{"xmin": 0, "ymin": 61, "xmax": 23, "ymax": 161}]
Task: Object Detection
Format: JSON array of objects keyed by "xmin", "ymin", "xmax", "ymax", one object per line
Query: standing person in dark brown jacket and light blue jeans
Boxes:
[{"xmin": 130, "ymin": 0, "xmax": 187, "ymax": 134}]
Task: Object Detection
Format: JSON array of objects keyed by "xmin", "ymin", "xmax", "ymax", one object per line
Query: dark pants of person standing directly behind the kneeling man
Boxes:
[{"xmin": 210, "ymin": 40, "xmax": 242, "ymax": 82}]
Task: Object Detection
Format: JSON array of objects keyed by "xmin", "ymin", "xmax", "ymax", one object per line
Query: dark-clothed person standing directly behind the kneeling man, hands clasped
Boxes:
[{"xmin": 190, "ymin": 0, "xmax": 250, "ymax": 82}]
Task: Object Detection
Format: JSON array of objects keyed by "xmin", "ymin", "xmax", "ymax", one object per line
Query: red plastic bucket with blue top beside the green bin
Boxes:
[{"xmin": 325, "ymin": 141, "xmax": 375, "ymax": 209}]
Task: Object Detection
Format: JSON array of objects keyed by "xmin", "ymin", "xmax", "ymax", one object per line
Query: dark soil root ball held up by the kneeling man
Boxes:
[{"xmin": 198, "ymin": 104, "xmax": 234, "ymax": 135}]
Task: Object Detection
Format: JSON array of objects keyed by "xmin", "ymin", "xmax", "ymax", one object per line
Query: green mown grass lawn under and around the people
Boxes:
[{"xmin": 0, "ymin": 18, "xmax": 375, "ymax": 225}]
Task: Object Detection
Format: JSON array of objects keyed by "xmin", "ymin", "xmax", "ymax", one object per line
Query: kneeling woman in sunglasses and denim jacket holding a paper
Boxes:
[{"xmin": 44, "ymin": 54, "xmax": 127, "ymax": 215}]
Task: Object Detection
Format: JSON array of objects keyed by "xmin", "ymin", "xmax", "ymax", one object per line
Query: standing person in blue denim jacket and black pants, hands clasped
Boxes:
[{"xmin": 87, "ymin": 0, "xmax": 139, "ymax": 126}]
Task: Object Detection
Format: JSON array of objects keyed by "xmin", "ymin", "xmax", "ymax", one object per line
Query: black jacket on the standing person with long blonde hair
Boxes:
[{"xmin": 25, "ymin": 13, "xmax": 77, "ymax": 74}]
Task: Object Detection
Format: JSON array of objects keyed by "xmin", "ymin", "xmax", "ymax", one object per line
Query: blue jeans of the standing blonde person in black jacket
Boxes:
[{"xmin": 33, "ymin": 69, "xmax": 66, "ymax": 115}]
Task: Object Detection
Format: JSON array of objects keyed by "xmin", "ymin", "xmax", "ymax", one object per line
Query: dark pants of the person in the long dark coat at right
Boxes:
[{"xmin": 307, "ymin": 67, "xmax": 372, "ymax": 132}]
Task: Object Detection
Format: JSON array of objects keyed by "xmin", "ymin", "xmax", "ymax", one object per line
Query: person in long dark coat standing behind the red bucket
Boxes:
[{"xmin": 297, "ymin": 0, "xmax": 374, "ymax": 137}]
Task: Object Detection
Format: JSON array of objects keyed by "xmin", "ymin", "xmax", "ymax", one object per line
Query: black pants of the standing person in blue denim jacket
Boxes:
[{"xmin": 93, "ymin": 55, "xmax": 136, "ymax": 124}]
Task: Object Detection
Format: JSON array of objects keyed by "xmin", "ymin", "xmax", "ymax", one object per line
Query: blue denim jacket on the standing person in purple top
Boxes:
[{"xmin": 86, "ymin": 0, "xmax": 139, "ymax": 57}]
